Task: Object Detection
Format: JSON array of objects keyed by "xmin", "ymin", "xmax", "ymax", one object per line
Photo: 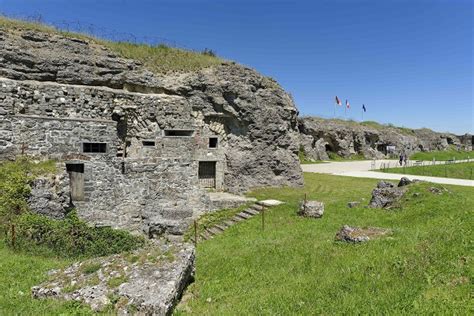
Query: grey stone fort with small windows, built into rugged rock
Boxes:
[{"xmin": 0, "ymin": 29, "xmax": 302, "ymax": 236}]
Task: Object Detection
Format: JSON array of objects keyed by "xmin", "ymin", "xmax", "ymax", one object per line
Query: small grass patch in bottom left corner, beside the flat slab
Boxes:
[{"xmin": 0, "ymin": 240, "xmax": 93, "ymax": 315}]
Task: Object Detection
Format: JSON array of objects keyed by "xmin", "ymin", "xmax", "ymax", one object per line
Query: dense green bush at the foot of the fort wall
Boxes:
[{"xmin": 16, "ymin": 212, "xmax": 145, "ymax": 257}]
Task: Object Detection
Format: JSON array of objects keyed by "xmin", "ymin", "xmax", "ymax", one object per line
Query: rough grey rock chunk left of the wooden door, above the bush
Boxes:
[{"xmin": 28, "ymin": 168, "xmax": 72, "ymax": 219}]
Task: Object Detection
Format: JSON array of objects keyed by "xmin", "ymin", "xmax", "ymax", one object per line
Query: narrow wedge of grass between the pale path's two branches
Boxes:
[{"xmin": 383, "ymin": 162, "xmax": 474, "ymax": 179}]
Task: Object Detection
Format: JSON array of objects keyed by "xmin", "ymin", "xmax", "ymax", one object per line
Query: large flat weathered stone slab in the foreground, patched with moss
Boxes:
[{"xmin": 31, "ymin": 241, "xmax": 195, "ymax": 315}]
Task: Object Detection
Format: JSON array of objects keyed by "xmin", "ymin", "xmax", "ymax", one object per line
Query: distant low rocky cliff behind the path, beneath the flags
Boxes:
[{"xmin": 299, "ymin": 117, "xmax": 466, "ymax": 160}]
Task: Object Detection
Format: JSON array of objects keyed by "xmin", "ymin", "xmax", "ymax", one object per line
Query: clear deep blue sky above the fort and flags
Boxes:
[{"xmin": 0, "ymin": 0, "xmax": 474, "ymax": 133}]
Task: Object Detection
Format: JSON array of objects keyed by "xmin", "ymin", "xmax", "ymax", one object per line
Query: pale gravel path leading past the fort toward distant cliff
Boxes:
[{"xmin": 301, "ymin": 160, "xmax": 474, "ymax": 187}]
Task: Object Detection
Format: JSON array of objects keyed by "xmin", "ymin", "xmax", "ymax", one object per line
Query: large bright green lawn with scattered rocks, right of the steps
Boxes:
[{"xmin": 177, "ymin": 174, "xmax": 474, "ymax": 315}]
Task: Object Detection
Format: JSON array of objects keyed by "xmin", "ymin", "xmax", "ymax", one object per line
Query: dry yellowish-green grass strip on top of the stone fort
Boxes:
[{"xmin": 0, "ymin": 15, "xmax": 225, "ymax": 74}]
